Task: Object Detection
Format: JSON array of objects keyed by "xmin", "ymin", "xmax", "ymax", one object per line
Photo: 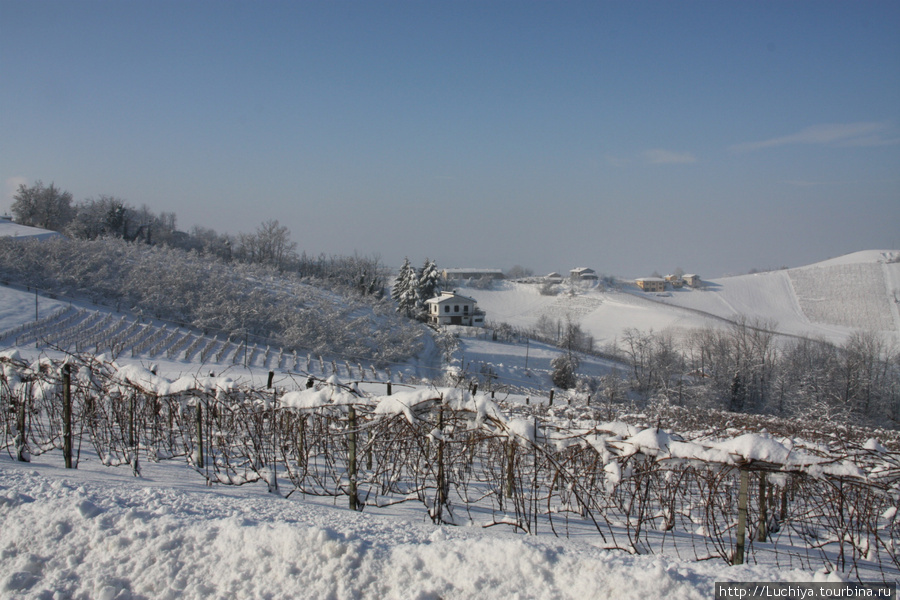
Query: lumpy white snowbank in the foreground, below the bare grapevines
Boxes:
[{"xmin": 0, "ymin": 455, "xmax": 825, "ymax": 600}]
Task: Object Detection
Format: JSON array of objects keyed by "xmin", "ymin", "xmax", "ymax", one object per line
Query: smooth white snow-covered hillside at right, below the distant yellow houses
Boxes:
[{"xmin": 467, "ymin": 250, "xmax": 900, "ymax": 347}]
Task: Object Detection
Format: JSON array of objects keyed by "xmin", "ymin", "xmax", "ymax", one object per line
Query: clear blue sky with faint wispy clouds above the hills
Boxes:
[{"xmin": 0, "ymin": 0, "xmax": 900, "ymax": 278}]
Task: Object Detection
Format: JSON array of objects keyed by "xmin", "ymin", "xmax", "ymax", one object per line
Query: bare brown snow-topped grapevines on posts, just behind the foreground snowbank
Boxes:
[{"xmin": 0, "ymin": 350, "xmax": 900, "ymax": 581}]
